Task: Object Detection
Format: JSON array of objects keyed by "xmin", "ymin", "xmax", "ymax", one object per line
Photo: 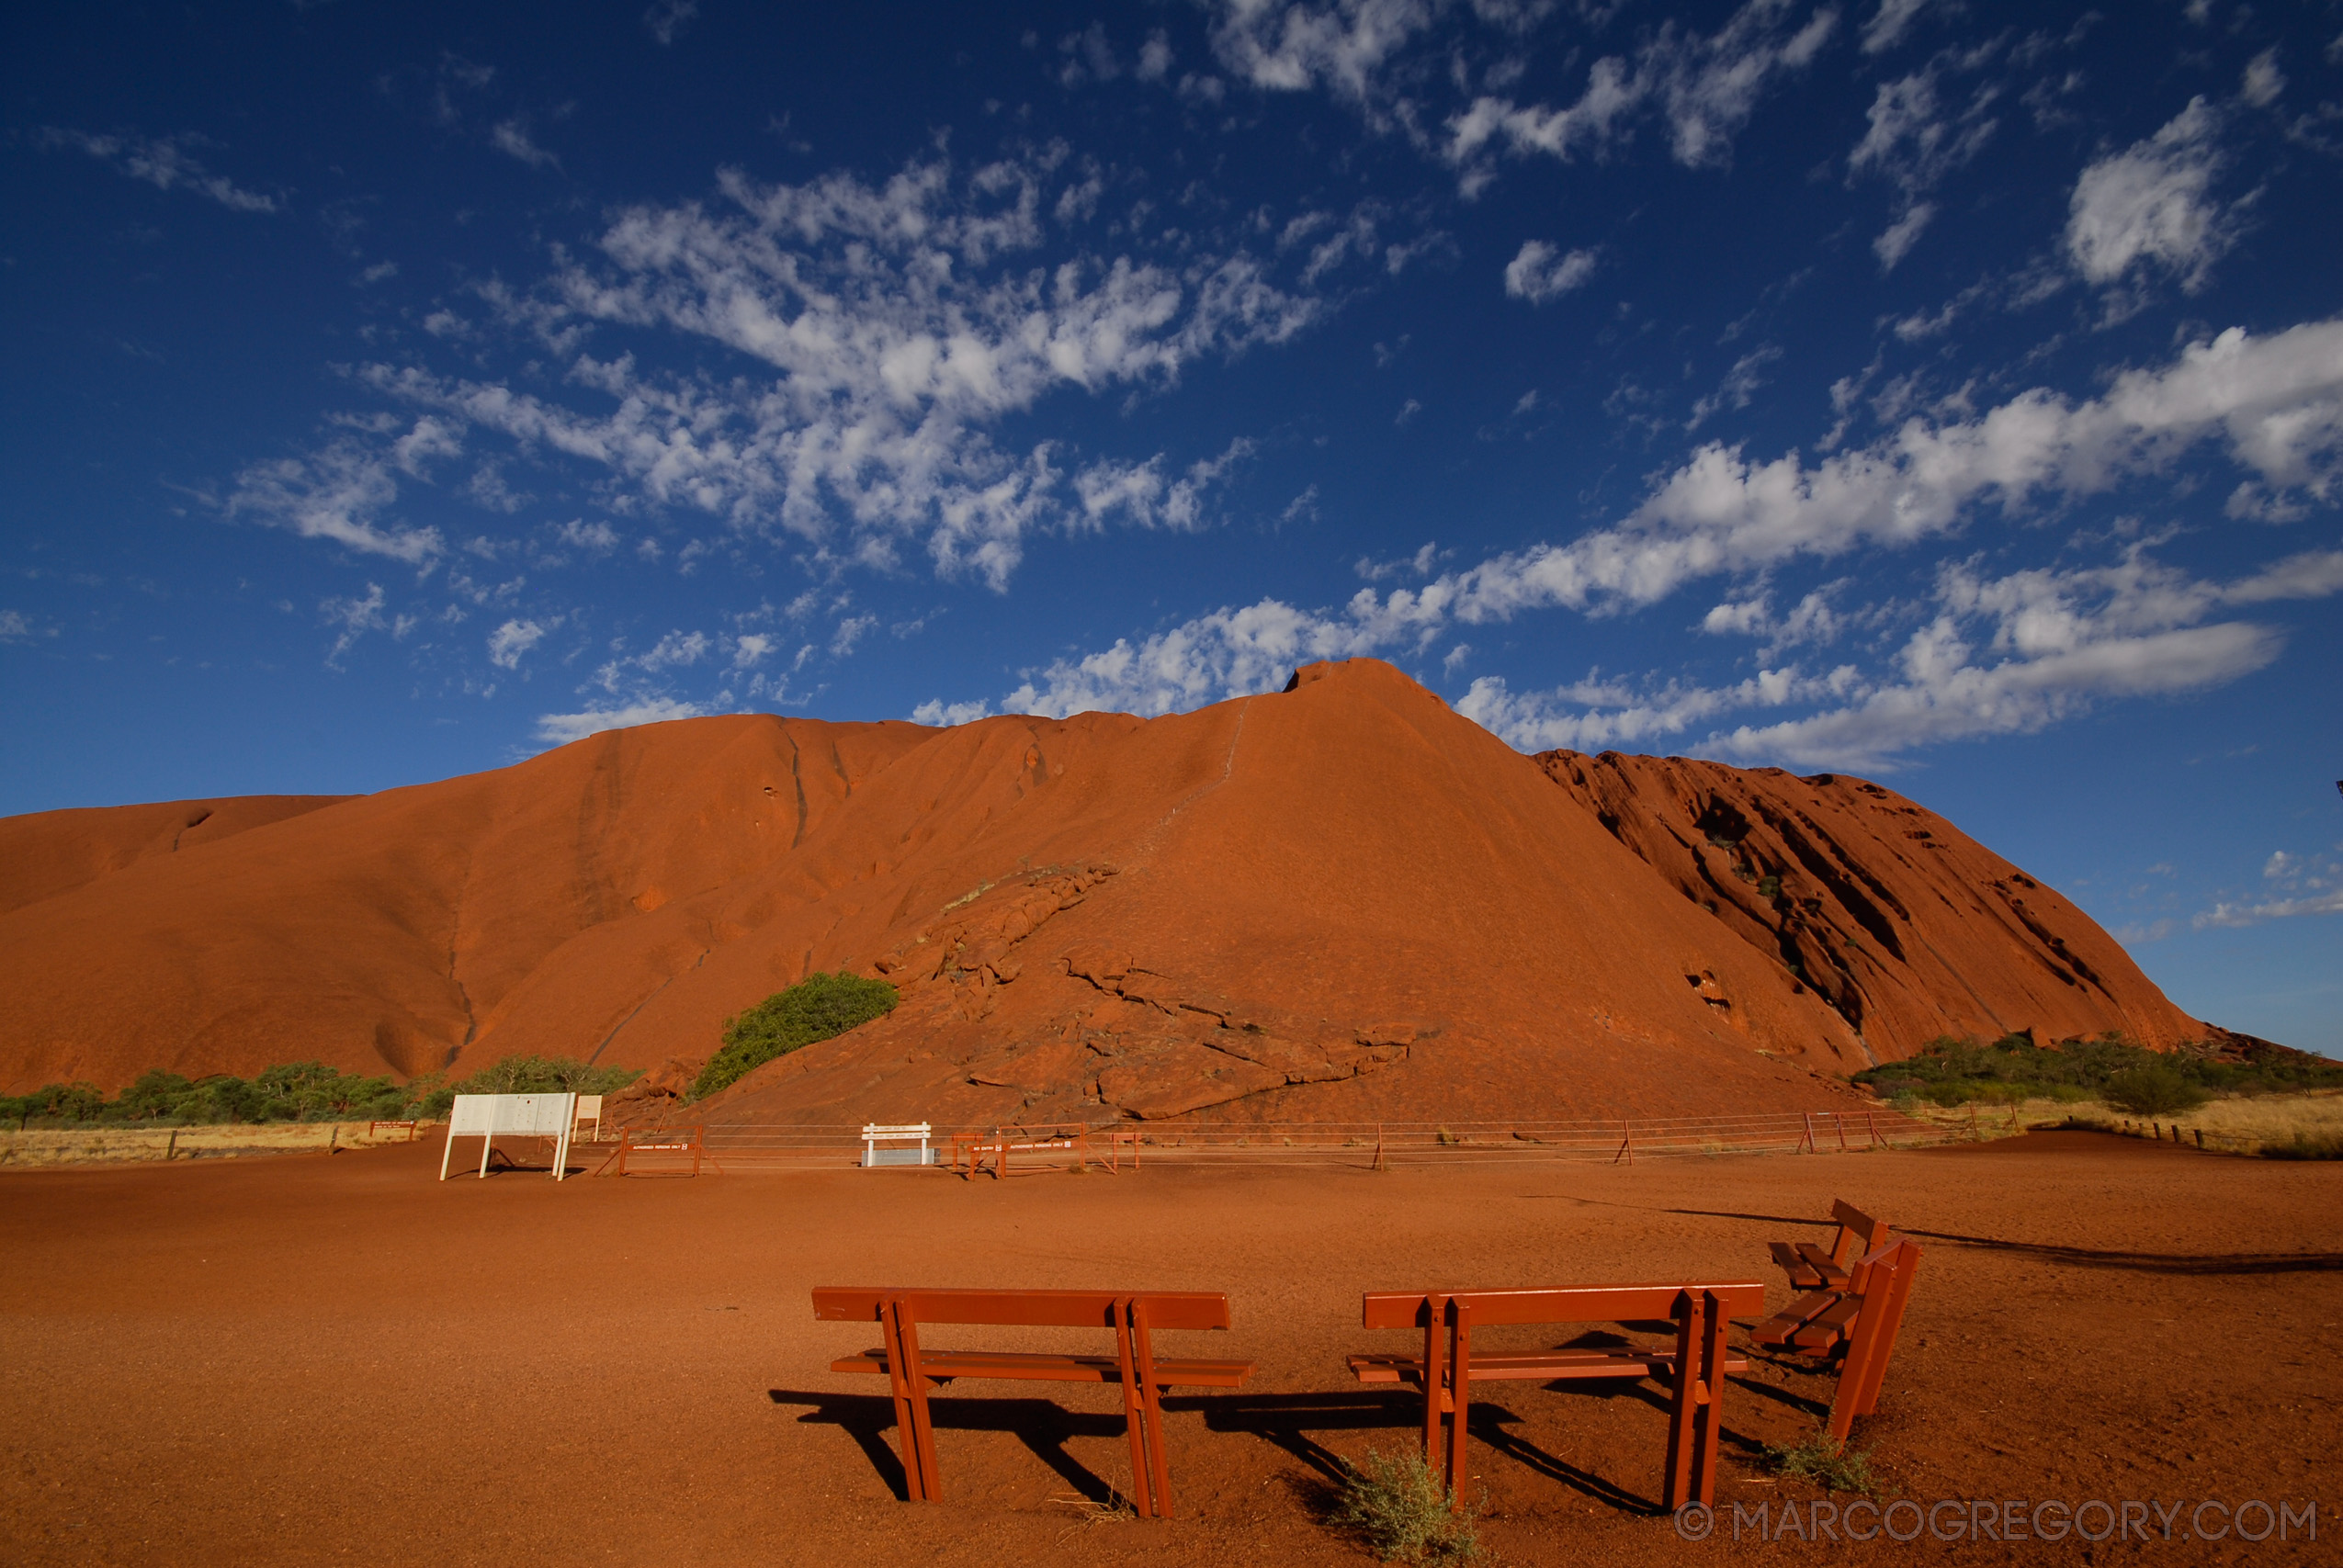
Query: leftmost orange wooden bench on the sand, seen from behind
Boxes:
[{"xmin": 813, "ymin": 1287, "xmax": 1253, "ymax": 1518}]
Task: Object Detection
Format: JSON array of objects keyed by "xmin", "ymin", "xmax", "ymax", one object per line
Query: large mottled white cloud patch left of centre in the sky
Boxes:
[{"xmin": 342, "ymin": 152, "xmax": 1329, "ymax": 588}]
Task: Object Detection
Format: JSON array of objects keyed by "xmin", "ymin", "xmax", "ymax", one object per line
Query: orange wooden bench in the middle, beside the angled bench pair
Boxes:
[{"xmin": 1350, "ymin": 1280, "xmax": 1764, "ymax": 1509}]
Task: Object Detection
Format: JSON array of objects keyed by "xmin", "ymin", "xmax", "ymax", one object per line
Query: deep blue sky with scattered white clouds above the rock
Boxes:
[{"xmin": 0, "ymin": 0, "xmax": 2343, "ymax": 1053}]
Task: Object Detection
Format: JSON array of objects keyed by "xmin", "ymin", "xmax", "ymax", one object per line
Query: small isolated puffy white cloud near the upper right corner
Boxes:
[{"xmin": 2066, "ymin": 98, "xmax": 2235, "ymax": 293}]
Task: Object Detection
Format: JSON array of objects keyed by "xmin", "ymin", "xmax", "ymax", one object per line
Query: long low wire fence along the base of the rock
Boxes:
[{"xmin": 684, "ymin": 1109, "xmax": 1973, "ymax": 1172}]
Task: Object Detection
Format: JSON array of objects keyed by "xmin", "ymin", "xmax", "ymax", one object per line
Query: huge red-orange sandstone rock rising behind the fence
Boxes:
[{"xmin": 0, "ymin": 659, "xmax": 2219, "ymax": 1122}]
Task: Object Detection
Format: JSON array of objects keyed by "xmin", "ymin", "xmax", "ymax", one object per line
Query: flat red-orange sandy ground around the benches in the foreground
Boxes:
[{"xmin": 0, "ymin": 1134, "xmax": 2343, "ymax": 1568}]
